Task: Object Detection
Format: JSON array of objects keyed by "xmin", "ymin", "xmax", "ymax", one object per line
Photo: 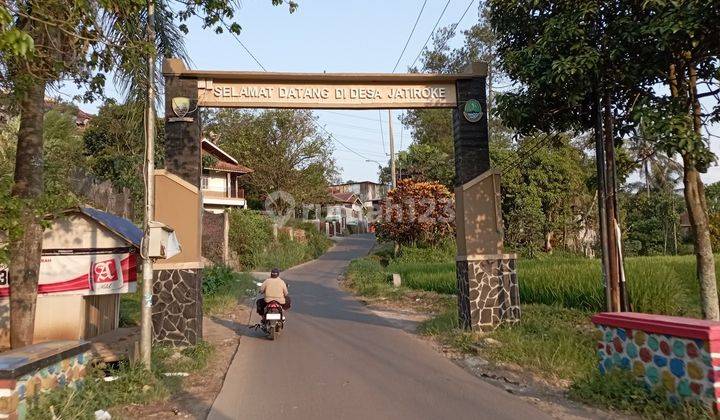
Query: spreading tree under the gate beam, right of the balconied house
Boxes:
[{"xmin": 202, "ymin": 110, "xmax": 337, "ymax": 210}]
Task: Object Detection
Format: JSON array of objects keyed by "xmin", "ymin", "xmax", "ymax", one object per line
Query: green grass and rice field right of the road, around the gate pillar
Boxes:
[{"xmin": 346, "ymin": 243, "xmax": 713, "ymax": 419}]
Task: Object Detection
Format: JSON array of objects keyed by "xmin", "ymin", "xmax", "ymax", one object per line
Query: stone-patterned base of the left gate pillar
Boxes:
[{"xmin": 152, "ymin": 269, "xmax": 203, "ymax": 347}]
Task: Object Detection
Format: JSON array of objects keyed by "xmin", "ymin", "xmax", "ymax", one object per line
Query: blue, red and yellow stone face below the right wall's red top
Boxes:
[{"xmin": 597, "ymin": 325, "xmax": 720, "ymax": 405}]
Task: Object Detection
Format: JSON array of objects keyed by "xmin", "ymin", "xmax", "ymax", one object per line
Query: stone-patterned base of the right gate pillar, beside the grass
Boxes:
[{"xmin": 456, "ymin": 254, "xmax": 520, "ymax": 331}]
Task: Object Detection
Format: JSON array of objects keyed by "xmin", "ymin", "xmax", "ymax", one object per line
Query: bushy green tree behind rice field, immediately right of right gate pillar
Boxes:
[{"xmin": 498, "ymin": 134, "xmax": 593, "ymax": 254}]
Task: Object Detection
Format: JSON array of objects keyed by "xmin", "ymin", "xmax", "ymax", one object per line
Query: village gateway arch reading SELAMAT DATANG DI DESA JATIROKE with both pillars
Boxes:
[{"xmin": 153, "ymin": 59, "xmax": 520, "ymax": 345}]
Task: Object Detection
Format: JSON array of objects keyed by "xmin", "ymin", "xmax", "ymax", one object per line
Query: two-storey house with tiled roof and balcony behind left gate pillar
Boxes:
[{"xmin": 201, "ymin": 139, "xmax": 253, "ymax": 213}]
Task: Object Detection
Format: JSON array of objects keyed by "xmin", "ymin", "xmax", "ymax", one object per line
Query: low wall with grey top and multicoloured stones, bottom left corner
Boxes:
[{"xmin": 0, "ymin": 341, "xmax": 91, "ymax": 419}]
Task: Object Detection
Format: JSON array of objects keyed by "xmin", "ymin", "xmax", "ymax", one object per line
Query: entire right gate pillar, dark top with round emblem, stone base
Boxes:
[{"xmin": 453, "ymin": 63, "xmax": 520, "ymax": 331}]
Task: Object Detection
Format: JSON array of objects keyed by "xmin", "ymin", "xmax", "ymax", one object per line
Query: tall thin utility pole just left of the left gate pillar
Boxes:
[{"xmin": 140, "ymin": 0, "xmax": 155, "ymax": 370}]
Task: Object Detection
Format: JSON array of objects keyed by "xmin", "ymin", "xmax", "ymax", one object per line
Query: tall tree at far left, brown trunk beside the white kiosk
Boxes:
[{"xmin": 0, "ymin": 0, "xmax": 296, "ymax": 347}]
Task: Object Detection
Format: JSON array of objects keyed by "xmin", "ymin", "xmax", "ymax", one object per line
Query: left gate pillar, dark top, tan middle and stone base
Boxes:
[{"xmin": 153, "ymin": 60, "xmax": 203, "ymax": 346}]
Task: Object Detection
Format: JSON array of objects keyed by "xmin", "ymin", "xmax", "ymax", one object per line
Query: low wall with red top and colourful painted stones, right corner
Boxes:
[{"xmin": 592, "ymin": 312, "xmax": 720, "ymax": 413}]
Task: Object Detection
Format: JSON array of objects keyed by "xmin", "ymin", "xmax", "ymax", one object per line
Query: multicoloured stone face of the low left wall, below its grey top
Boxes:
[{"xmin": 0, "ymin": 352, "xmax": 91, "ymax": 420}]
